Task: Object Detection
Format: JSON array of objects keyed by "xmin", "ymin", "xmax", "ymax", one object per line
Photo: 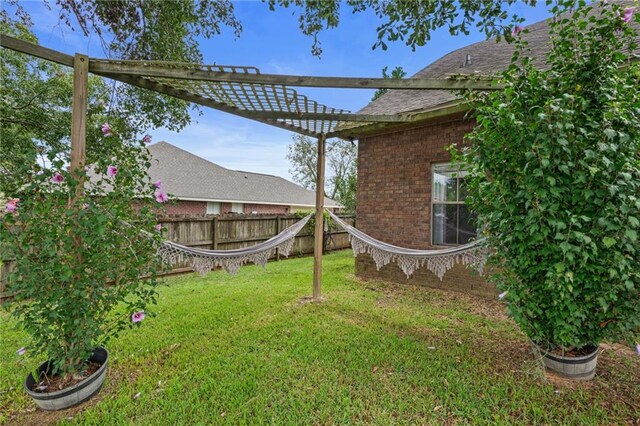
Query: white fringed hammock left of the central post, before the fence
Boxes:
[{"xmin": 158, "ymin": 214, "xmax": 311, "ymax": 275}]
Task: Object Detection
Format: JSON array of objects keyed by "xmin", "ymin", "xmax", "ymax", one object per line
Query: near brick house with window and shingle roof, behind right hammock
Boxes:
[{"xmin": 342, "ymin": 9, "xmax": 636, "ymax": 295}]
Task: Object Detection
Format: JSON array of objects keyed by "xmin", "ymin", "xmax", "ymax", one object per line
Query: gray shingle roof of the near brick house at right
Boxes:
[{"xmin": 358, "ymin": 0, "xmax": 631, "ymax": 114}]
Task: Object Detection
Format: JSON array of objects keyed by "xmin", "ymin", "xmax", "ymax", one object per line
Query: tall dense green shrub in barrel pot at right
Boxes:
[{"xmin": 457, "ymin": 0, "xmax": 640, "ymax": 380}]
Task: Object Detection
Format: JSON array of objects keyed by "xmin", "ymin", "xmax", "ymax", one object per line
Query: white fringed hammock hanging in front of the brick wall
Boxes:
[{"xmin": 327, "ymin": 210, "xmax": 487, "ymax": 281}]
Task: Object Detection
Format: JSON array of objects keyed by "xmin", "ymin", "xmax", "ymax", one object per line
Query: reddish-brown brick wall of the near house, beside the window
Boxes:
[{"xmin": 356, "ymin": 115, "xmax": 495, "ymax": 296}]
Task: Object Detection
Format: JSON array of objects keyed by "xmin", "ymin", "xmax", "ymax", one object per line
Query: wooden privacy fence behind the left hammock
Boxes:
[{"xmin": 0, "ymin": 215, "xmax": 355, "ymax": 298}]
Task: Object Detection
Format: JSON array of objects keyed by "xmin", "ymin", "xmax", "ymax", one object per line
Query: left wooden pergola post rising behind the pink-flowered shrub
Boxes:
[{"xmin": 70, "ymin": 53, "xmax": 89, "ymax": 198}]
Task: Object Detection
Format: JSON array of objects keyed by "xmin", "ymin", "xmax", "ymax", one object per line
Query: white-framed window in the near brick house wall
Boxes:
[{"xmin": 431, "ymin": 164, "xmax": 476, "ymax": 245}]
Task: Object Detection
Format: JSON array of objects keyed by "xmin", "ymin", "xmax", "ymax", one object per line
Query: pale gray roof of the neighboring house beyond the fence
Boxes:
[{"xmin": 148, "ymin": 142, "xmax": 341, "ymax": 208}]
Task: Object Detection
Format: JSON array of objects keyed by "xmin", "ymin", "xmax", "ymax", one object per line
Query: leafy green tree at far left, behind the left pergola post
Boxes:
[{"xmin": 0, "ymin": 23, "xmax": 116, "ymax": 193}]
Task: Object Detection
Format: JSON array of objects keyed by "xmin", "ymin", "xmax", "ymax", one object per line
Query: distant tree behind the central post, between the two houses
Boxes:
[{"xmin": 287, "ymin": 135, "xmax": 358, "ymax": 211}]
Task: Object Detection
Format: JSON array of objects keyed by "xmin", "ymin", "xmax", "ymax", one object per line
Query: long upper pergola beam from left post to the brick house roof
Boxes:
[{"xmin": 89, "ymin": 60, "xmax": 503, "ymax": 90}]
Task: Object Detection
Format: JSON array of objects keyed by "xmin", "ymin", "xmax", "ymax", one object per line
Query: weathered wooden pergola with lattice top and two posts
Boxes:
[{"xmin": 0, "ymin": 34, "xmax": 501, "ymax": 298}]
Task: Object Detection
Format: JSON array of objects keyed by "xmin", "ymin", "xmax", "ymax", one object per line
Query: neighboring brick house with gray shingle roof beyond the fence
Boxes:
[{"xmin": 148, "ymin": 142, "xmax": 341, "ymax": 216}]
